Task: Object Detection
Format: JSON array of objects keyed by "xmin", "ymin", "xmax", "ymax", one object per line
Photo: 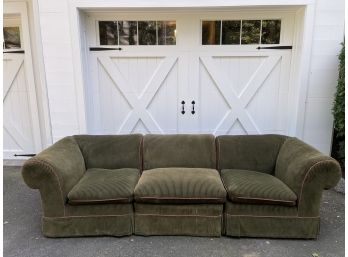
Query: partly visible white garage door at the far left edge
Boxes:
[{"xmin": 3, "ymin": 6, "xmax": 41, "ymax": 159}]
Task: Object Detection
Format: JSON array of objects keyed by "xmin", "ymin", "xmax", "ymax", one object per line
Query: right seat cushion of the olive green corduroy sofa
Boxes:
[{"xmin": 221, "ymin": 169, "xmax": 297, "ymax": 206}]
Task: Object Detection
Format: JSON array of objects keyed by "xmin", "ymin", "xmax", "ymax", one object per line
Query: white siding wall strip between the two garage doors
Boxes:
[{"xmin": 38, "ymin": 0, "xmax": 79, "ymax": 142}]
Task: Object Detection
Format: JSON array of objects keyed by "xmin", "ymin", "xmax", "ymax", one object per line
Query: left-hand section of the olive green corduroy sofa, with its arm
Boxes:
[{"xmin": 22, "ymin": 135, "xmax": 142, "ymax": 237}]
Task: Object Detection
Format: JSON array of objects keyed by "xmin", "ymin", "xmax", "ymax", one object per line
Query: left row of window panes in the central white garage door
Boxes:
[{"xmin": 98, "ymin": 21, "xmax": 176, "ymax": 45}]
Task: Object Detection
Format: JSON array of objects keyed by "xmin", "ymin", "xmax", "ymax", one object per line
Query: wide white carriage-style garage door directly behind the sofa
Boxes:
[{"xmin": 86, "ymin": 11, "xmax": 294, "ymax": 134}]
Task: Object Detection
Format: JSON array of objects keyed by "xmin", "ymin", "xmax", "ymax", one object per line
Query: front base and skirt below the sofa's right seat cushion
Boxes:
[{"xmin": 224, "ymin": 202, "xmax": 320, "ymax": 239}]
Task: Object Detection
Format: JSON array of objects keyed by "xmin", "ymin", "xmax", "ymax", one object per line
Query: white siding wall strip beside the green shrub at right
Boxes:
[{"xmin": 303, "ymin": 0, "xmax": 344, "ymax": 154}]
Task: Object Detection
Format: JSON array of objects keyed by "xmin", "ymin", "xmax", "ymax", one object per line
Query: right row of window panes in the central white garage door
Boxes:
[{"xmin": 202, "ymin": 20, "xmax": 281, "ymax": 45}]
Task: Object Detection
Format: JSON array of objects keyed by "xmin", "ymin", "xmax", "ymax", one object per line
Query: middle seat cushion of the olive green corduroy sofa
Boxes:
[{"xmin": 134, "ymin": 168, "xmax": 226, "ymax": 204}]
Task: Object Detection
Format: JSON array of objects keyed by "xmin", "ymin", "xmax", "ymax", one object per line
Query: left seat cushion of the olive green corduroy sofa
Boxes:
[{"xmin": 68, "ymin": 168, "xmax": 140, "ymax": 205}]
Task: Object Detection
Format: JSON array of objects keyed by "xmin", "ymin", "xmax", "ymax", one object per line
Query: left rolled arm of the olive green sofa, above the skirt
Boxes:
[{"xmin": 22, "ymin": 137, "xmax": 86, "ymax": 217}]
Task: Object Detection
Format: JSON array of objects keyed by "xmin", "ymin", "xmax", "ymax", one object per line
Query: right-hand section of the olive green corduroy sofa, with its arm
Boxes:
[{"xmin": 217, "ymin": 135, "xmax": 341, "ymax": 238}]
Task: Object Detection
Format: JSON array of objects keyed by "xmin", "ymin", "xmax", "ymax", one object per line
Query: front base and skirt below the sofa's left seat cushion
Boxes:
[{"xmin": 42, "ymin": 204, "xmax": 134, "ymax": 237}]
